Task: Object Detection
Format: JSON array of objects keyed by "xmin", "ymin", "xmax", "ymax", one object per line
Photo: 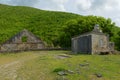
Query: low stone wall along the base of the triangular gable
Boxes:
[{"xmin": 1, "ymin": 43, "xmax": 44, "ymax": 52}]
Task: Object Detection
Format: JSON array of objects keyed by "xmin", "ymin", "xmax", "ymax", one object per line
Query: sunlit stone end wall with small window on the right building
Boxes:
[{"xmin": 92, "ymin": 34, "xmax": 109, "ymax": 54}]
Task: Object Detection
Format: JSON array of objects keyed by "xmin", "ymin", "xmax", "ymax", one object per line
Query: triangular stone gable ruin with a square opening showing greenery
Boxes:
[{"xmin": 0, "ymin": 29, "xmax": 45, "ymax": 52}]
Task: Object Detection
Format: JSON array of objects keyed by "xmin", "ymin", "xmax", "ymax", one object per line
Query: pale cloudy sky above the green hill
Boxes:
[{"xmin": 0, "ymin": 0, "xmax": 120, "ymax": 26}]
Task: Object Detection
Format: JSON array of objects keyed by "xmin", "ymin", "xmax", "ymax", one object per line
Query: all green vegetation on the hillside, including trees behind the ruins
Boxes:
[{"xmin": 0, "ymin": 4, "xmax": 120, "ymax": 50}]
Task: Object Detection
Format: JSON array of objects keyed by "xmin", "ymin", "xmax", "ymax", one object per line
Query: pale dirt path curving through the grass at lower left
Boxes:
[{"xmin": 0, "ymin": 52, "xmax": 38, "ymax": 80}]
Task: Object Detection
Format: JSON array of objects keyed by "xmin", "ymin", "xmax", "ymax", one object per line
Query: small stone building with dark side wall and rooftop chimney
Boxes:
[{"xmin": 72, "ymin": 25, "xmax": 114, "ymax": 54}]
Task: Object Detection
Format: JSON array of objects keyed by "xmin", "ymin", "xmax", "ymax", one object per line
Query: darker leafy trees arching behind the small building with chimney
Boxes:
[{"xmin": 59, "ymin": 15, "xmax": 120, "ymax": 49}]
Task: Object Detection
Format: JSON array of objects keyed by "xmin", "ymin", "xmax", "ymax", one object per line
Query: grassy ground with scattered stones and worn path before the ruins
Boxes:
[{"xmin": 0, "ymin": 51, "xmax": 120, "ymax": 80}]
